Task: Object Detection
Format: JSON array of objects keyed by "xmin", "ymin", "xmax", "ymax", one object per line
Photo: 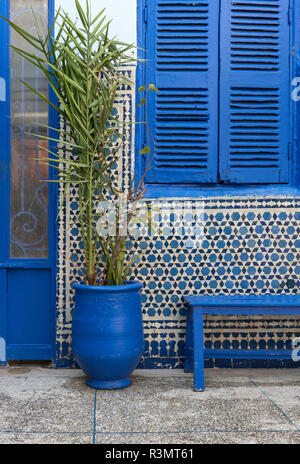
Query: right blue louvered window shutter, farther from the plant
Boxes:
[{"xmin": 220, "ymin": 0, "xmax": 290, "ymax": 183}]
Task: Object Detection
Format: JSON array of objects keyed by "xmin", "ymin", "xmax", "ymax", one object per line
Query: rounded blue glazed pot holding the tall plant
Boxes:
[{"xmin": 73, "ymin": 282, "xmax": 144, "ymax": 389}]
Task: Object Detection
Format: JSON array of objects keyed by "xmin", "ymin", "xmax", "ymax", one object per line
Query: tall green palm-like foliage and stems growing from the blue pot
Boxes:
[{"xmin": 3, "ymin": 0, "xmax": 157, "ymax": 285}]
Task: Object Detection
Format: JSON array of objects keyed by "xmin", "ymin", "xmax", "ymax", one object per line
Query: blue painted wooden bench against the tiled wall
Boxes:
[{"xmin": 184, "ymin": 295, "xmax": 300, "ymax": 391}]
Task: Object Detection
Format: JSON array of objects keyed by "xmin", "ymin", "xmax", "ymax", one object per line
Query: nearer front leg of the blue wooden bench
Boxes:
[{"xmin": 193, "ymin": 309, "xmax": 205, "ymax": 391}]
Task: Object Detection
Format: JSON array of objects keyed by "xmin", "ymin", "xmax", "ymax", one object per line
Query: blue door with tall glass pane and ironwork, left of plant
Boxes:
[{"xmin": 0, "ymin": 0, "xmax": 56, "ymax": 362}]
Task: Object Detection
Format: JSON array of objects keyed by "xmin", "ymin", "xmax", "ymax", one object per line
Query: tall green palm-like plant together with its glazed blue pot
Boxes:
[{"xmin": 3, "ymin": 0, "xmax": 157, "ymax": 389}]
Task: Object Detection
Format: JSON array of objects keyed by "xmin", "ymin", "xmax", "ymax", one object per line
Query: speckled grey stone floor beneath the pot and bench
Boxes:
[{"xmin": 0, "ymin": 364, "xmax": 300, "ymax": 444}]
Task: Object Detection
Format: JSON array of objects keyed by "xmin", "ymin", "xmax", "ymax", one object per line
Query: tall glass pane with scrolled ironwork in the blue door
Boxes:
[{"xmin": 10, "ymin": 0, "xmax": 49, "ymax": 258}]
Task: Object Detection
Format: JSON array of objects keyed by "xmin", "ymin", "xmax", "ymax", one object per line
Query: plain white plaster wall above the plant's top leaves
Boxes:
[{"xmin": 55, "ymin": 0, "xmax": 137, "ymax": 43}]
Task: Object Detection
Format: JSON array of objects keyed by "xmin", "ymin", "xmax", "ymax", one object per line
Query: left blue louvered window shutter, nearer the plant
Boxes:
[{"xmin": 145, "ymin": 0, "xmax": 219, "ymax": 184}]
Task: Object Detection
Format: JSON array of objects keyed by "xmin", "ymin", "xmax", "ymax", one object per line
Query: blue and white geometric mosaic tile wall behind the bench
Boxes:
[{"xmin": 57, "ymin": 69, "xmax": 300, "ymax": 368}]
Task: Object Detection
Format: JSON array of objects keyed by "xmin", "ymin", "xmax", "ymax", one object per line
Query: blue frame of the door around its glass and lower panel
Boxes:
[{"xmin": 0, "ymin": 0, "xmax": 58, "ymax": 365}]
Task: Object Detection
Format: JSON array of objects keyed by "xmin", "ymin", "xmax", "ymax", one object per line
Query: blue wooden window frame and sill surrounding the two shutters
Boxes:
[{"xmin": 135, "ymin": 0, "xmax": 300, "ymax": 198}]
